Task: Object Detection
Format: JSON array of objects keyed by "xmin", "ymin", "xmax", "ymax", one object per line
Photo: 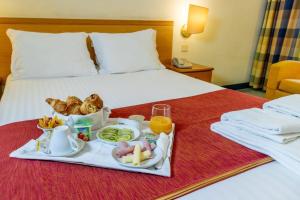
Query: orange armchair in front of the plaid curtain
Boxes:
[{"xmin": 266, "ymin": 60, "xmax": 300, "ymax": 99}]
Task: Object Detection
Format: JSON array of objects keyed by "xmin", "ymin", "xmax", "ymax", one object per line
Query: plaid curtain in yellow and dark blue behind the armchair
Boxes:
[{"xmin": 250, "ymin": 0, "xmax": 300, "ymax": 89}]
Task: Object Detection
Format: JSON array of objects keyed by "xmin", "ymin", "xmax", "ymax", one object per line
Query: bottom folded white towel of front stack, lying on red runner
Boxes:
[{"xmin": 211, "ymin": 122, "xmax": 300, "ymax": 175}]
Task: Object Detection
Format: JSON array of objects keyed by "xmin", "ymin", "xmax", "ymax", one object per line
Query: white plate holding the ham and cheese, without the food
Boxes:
[{"xmin": 111, "ymin": 141, "xmax": 163, "ymax": 169}]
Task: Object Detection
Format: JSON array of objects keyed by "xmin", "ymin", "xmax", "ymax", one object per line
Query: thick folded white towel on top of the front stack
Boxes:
[{"xmin": 221, "ymin": 108, "xmax": 300, "ymax": 135}]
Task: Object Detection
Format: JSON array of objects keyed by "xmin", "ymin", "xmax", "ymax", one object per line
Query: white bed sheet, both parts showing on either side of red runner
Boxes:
[{"xmin": 0, "ymin": 70, "xmax": 300, "ymax": 200}]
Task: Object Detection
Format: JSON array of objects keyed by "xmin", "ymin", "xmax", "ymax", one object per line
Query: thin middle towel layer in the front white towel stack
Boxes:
[{"xmin": 222, "ymin": 121, "xmax": 300, "ymax": 144}]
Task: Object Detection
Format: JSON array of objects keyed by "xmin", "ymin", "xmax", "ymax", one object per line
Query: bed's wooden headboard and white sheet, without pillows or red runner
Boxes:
[{"xmin": 0, "ymin": 19, "xmax": 300, "ymax": 200}]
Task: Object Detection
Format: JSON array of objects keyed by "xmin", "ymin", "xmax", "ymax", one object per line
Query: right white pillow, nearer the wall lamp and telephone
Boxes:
[{"xmin": 90, "ymin": 29, "xmax": 162, "ymax": 73}]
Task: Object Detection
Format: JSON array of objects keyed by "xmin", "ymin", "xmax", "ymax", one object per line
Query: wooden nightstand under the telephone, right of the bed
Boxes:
[{"xmin": 167, "ymin": 64, "xmax": 214, "ymax": 82}]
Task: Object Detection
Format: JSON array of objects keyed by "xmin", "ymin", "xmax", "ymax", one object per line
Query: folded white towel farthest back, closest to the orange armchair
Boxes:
[{"xmin": 263, "ymin": 94, "xmax": 300, "ymax": 118}]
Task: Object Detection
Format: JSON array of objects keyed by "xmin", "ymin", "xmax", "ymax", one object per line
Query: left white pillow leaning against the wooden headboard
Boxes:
[{"xmin": 7, "ymin": 29, "xmax": 97, "ymax": 79}]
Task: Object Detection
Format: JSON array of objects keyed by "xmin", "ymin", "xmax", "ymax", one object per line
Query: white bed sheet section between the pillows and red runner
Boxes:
[{"xmin": 0, "ymin": 69, "xmax": 222, "ymax": 125}]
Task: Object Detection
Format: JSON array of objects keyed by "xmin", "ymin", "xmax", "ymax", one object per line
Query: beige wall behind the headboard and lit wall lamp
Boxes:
[{"xmin": 0, "ymin": 0, "xmax": 265, "ymax": 85}]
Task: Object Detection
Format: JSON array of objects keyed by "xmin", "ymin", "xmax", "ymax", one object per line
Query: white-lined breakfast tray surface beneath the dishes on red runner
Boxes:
[{"xmin": 10, "ymin": 119, "xmax": 175, "ymax": 177}]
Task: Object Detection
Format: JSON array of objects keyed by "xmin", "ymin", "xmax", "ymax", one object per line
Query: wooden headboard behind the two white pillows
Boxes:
[{"xmin": 0, "ymin": 18, "xmax": 173, "ymax": 79}]
